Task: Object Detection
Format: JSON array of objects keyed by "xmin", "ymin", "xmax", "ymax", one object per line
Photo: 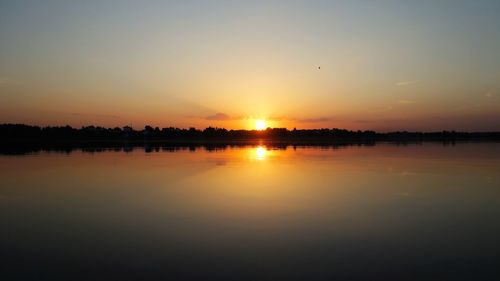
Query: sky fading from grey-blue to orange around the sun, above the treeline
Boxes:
[{"xmin": 0, "ymin": 0, "xmax": 500, "ymax": 131}]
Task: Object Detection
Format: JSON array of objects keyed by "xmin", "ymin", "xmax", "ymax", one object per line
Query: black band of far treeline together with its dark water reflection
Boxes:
[{"xmin": 0, "ymin": 124, "xmax": 500, "ymax": 154}]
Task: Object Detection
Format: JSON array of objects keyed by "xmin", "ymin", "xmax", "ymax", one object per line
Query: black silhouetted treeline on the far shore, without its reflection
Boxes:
[{"xmin": 0, "ymin": 124, "xmax": 500, "ymax": 144}]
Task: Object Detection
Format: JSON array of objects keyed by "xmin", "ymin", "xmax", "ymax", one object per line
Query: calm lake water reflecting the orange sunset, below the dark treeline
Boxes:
[{"xmin": 0, "ymin": 143, "xmax": 500, "ymax": 280}]
